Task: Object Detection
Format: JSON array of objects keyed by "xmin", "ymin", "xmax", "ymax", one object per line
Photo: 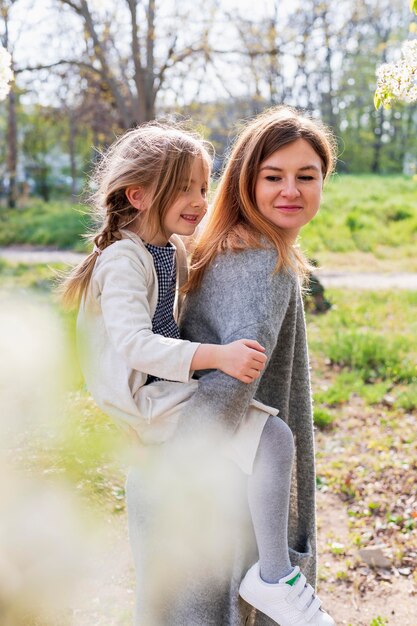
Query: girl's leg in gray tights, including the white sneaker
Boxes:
[{"xmin": 239, "ymin": 417, "xmax": 335, "ymax": 626}]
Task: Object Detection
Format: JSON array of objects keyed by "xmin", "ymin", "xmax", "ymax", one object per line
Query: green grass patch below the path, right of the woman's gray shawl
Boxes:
[{"xmin": 308, "ymin": 290, "xmax": 417, "ymax": 420}]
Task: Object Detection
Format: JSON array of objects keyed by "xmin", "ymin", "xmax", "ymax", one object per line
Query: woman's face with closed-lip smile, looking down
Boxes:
[{"xmin": 255, "ymin": 139, "xmax": 323, "ymax": 239}]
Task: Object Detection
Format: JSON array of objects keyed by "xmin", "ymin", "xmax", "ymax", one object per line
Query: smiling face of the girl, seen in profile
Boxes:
[{"xmin": 156, "ymin": 157, "xmax": 210, "ymax": 245}]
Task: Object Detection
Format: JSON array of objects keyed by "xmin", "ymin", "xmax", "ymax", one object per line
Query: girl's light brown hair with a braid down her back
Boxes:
[{"xmin": 59, "ymin": 122, "xmax": 211, "ymax": 307}]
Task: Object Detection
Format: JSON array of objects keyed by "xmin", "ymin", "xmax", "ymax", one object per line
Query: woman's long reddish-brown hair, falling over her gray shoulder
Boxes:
[{"xmin": 184, "ymin": 106, "xmax": 336, "ymax": 292}]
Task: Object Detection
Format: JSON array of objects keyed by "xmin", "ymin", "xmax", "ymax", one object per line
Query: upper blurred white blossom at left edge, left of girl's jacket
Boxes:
[{"xmin": 0, "ymin": 295, "xmax": 66, "ymax": 442}]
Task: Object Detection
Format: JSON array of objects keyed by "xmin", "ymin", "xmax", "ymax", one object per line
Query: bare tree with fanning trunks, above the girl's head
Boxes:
[{"xmin": 57, "ymin": 0, "xmax": 211, "ymax": 128}]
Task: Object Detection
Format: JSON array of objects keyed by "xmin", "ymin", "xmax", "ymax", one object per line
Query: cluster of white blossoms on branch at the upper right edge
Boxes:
[{"xmin": 374, "ymin": 39, "xmax": 417, "ymax": 108}]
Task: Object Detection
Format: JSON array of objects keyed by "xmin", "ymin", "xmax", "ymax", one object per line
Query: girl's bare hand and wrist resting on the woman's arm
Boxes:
[{"xmin": 191, "ymin": 339, "xmax": 267, "ymax": 383}]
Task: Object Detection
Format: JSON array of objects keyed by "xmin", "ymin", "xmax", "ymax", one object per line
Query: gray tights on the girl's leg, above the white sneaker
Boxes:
[{"xmin": 248, "ymin": 416, "xmax": 294, "ymax": 583}]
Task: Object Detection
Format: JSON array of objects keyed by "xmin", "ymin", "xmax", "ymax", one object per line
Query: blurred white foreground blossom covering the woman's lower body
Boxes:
[{"xmin": 127, "ymin": 430, "xmax": 252, "ymax": 614}]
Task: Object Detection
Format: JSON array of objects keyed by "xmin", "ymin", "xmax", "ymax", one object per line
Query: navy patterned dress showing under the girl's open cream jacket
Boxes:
[{"xmin": 145, "ymin": 242, "xmax": 180, "ymax": 385}]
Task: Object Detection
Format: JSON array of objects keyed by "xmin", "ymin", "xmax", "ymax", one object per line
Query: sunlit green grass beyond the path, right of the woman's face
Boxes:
[{"xmin": 301, "ymin": 175, "xmax": 417, "ymax": 263}]
